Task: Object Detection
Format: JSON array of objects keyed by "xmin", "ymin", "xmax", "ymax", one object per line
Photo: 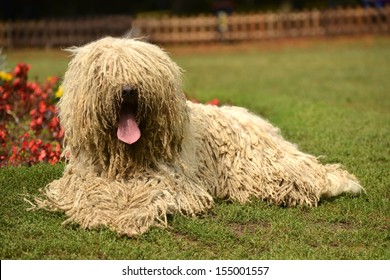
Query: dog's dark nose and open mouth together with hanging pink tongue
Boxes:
[{"xmin": 117, "ymin": 86, "xmax": 141, "ymax": 144}]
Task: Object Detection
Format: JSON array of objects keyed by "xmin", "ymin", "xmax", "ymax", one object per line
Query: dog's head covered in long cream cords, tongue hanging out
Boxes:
[{"xmin": 59, "ymin": 37, "xmax": 188, "ymax": 174}]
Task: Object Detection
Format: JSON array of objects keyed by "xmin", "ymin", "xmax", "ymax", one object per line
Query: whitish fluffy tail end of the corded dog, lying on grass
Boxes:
[{"xmin": 321, "ymin": 164, "xmax": 366, "ymax": 198}]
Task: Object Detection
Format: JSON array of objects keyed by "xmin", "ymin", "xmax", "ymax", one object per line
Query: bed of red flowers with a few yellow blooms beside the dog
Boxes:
[{"xmin": 0, "ymin": 63, "xmax": 64, "ymax": 167}]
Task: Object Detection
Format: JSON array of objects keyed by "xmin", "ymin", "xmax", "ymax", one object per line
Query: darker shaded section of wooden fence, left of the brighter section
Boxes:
[{"xmin": 0, "ymin": 16, "xmax": 132, "ymax": 48}]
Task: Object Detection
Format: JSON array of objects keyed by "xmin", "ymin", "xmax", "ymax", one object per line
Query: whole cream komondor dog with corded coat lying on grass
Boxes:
[{"xmin": 37, "ymin": 37, "xmax": 363, "ymax": 236}]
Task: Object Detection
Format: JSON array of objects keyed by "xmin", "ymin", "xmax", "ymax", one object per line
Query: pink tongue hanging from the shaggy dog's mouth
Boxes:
[{"xmin": 117, "ymin": 113, "xmax": 141, "ymax": 144}]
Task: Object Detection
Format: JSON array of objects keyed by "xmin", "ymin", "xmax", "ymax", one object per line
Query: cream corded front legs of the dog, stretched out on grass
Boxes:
[{"xmin": 36, "ymin": 168, "xmax": 213, "ymax": 236}]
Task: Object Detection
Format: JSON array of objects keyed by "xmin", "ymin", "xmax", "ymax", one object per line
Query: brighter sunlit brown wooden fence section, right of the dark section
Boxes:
[{"xmin": 133, "ymin": 6, "xmax": 390, "ymax": 44}]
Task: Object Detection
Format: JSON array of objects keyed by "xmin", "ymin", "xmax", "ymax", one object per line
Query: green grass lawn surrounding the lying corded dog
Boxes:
[{"xmin": 0, "ymin": 38, "xmax": 390, "ymax": 259}]
